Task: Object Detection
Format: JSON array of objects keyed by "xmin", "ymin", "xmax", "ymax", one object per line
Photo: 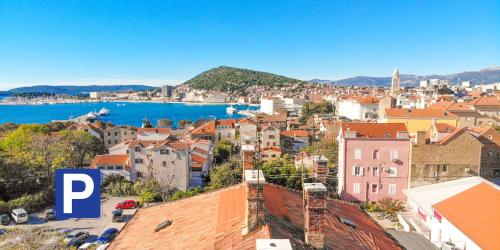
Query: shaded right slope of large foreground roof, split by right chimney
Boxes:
[{"xmin": 264, "ymin": 184, "xmax": 402, "ymax": 249}]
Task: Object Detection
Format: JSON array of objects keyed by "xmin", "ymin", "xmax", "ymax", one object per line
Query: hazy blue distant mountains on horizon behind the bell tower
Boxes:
[{"xmin": 308, "ymin": 67, "xmax": 500, "ymax": 87}]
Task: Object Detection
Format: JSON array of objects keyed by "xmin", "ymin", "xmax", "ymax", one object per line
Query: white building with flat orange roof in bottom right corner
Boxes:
[{"xmin": 398, "ymin": 177, "xmax": 500, "ymax": 250}]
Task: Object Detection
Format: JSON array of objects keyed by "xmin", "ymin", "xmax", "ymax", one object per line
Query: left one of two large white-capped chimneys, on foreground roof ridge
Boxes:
[{"xmin": 243, "ymin": 170, "xmax": 266, "ymax": 235}]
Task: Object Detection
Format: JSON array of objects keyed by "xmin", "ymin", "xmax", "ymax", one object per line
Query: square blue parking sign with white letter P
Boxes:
[{"xmin": 55, "ymin": 169, "xmax": 101, "ymax": 219}]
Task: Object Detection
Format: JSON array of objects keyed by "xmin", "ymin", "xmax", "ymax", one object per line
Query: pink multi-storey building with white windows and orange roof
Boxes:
[{"xmin": 338, "ymin": 123, "xmax": 410, "ymax": 202}]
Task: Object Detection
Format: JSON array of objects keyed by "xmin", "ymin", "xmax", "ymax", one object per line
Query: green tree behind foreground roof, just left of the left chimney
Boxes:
[{"xmin": 208, "ymin": 161, "xmax": 243, "ymax": 190}]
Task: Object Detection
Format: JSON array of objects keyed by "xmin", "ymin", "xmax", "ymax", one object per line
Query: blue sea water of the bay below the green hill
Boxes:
[{"xmin": 0, "ymin": 102, "xmax": 258, "ymax": 126}]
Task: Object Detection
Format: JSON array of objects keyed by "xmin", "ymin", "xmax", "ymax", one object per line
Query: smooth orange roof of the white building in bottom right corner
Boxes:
[{"xmin": 432, "ymin": 183, "xmax": 500, "ymax": 249}]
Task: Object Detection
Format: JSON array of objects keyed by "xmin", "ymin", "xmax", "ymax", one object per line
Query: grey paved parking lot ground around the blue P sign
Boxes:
[{"xmin": 0, "ymin": 197, "xmax": 137, "ymax": 239}]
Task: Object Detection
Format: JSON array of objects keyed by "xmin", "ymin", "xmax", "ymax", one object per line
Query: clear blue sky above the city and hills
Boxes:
[{"xmin": 0, "ymin": 0, "xmax": 500, "ymax": 90}]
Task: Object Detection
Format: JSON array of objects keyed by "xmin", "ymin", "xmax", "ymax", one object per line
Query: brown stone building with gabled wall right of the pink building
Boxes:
[{"xmin": 409, "ymin": 128, "xmax": 482, "ymax": 187}]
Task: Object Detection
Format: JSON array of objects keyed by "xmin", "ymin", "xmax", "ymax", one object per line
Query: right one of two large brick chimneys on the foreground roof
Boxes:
[{"xmin": 304, "ymin": 183, "xmax": 326, "ymax": 249}]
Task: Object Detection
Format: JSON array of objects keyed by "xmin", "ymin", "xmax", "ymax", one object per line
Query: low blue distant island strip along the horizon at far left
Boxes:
[{"xmin": 0, "ymin": 85, "xmax": 155, "ymax": 95}]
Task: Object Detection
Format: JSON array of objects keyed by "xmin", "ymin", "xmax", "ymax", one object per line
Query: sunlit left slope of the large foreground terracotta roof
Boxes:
[{"xmin": 108, "ymin": 185, "xmax": 270, "ymax": 250}]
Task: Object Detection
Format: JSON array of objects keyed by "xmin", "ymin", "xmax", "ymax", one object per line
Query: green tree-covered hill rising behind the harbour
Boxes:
[{"xmin": 184, "ymin": 66, "xmax": 305, "ymax": 91}]
